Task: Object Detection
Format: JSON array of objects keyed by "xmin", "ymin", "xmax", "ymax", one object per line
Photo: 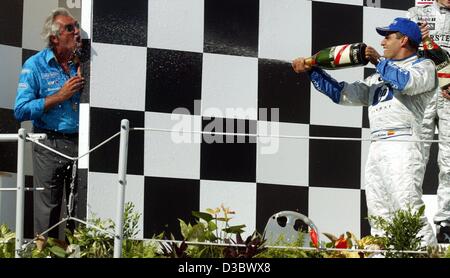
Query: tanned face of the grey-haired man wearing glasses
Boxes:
[{"xmin": 54, "ymin": 15, "xmax": 81, "ymax": 52}]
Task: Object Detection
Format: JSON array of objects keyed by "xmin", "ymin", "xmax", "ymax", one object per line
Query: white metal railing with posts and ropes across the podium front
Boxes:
[{"xmin": 0, "ymin": 119, "xmax": 450, "ymax": 258}]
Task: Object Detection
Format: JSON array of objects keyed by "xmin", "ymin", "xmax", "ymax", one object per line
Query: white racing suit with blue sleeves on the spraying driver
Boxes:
[{"xmin": 309, "ymin": 55, "xmax": 438, "ymax": 246}]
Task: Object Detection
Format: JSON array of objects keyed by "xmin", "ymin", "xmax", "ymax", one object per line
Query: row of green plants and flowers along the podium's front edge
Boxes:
[{"xmin": 0, "ymin": 203, "xmax": 450, "ymax": 258}]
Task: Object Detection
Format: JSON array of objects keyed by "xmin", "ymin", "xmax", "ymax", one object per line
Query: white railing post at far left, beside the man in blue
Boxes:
[{"xmin": 15, "ymin": 128, "xmax": 27, "ymax": 258}]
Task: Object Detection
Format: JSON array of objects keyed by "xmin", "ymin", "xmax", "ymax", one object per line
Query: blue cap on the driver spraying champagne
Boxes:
[{"xmin": 377, "ymin": 17, "xmax": 422, "ymax": 45}]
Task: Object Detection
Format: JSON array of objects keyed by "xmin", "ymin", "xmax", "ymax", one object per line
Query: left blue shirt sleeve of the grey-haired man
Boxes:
[{"xmin": 14, "ymin": 64, "xmax": 45, "ymax": 122}]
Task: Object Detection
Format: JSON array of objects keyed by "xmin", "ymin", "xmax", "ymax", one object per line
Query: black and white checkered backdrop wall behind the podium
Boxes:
[{"xmin": 0, "ymin": 0, "xmax": 437, "ymax": 240}]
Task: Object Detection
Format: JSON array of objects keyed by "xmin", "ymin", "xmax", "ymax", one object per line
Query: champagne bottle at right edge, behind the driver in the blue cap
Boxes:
[{"xmin": 422, "ymin": 37, "xmax": 450, "ymax": 90}]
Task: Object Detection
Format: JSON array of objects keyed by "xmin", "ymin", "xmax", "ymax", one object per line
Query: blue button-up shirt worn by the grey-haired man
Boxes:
[{"xmin": 14, "ymin": 48, "xmax": 80, "ymax": 133}]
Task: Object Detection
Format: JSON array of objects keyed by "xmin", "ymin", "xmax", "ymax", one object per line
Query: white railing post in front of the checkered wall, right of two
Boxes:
[{"xmin": 114, "ymin": 119, "xmax": 130, "ymax": 258}]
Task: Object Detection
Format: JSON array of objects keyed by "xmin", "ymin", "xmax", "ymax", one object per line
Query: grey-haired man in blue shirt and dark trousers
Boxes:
[{"xmin": 14, "ymin": 8, "xmax": 84, "ymax": 238}]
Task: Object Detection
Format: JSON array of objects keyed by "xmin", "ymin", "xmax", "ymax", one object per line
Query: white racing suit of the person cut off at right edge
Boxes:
[{"xmin": 407, "ymin": 2, "xmax": 450, "ymax": 228}]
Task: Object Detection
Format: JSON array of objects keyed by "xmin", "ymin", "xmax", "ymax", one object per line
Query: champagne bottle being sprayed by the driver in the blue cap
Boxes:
[{"xmin": 305, "ymin": 43, "xmax": 369, "ymax": 69}]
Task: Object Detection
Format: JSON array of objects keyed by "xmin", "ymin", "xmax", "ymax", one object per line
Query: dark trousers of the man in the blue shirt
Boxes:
[{"xmin": 33, "ymin": 128, "xmax": 78, "ymax": 238}]
